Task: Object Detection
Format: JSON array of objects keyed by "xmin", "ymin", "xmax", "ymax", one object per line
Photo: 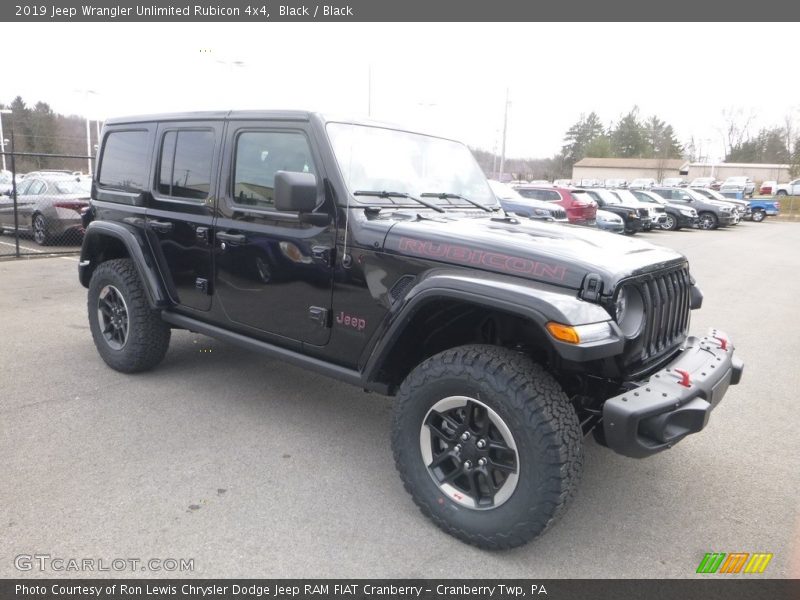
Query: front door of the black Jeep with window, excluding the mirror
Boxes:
[{"xmin": 214, "ymin": 121, "xmax": 336, "ymax": 345}]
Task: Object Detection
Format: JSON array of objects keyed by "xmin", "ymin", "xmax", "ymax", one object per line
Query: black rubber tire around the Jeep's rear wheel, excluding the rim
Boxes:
[{"xmin": 87, "ymin": 258, "xmax": 171, "ymax": 373}]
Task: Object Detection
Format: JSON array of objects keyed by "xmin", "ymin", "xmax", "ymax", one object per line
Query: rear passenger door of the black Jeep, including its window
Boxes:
[{"xmin": 147, "ymin": 121, "xmax": 223, "ymax": 311}]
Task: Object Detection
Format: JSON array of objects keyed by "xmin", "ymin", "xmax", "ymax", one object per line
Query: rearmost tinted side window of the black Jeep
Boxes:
[{"xmin": 97, "ymin": 131, "xmax": 149, "ymax": 192}]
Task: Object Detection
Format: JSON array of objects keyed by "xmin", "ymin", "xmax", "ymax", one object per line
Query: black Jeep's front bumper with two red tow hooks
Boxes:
[{"xmin": 602, "ymin": 329, "xmax": 744, "ymax": 458}]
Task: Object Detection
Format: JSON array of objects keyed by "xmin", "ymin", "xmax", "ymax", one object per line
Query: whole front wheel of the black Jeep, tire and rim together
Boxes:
[{"xmin": 392, "ymin": 345, "xmax": 583, "ymax": 549}]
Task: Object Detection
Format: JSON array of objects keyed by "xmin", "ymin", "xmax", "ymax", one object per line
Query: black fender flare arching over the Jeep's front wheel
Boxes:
[{"xmin": 362, "ymin": 269, "xmax": 624, "ymax": 385}]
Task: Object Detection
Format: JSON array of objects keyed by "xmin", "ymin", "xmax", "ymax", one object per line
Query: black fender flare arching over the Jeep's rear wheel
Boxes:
[{"xmin": 78, "ymin": 221, "xmax": 172, "ymax": 308}]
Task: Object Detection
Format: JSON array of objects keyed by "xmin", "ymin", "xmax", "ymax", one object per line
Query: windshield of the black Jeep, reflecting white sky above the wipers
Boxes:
[{"xmin": 327, "ymin": 123, "xmax": 497, "ymax": 206}]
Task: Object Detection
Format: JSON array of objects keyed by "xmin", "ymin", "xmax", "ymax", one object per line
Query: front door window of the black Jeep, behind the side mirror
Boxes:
[{"xmin": 233, "ymin": 131, "xmax": 315, "ymax": 208}]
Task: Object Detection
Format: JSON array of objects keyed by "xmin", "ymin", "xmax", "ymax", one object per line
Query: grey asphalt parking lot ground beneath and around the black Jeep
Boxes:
[{"xmin": 0, "ymin": 220, "xmax": 800, "ymax": 578}]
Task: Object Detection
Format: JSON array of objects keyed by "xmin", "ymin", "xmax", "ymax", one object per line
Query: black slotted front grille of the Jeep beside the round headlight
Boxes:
[{"xmin": 627, "ymin": 266, "xmax": 691, "ymax": 368}]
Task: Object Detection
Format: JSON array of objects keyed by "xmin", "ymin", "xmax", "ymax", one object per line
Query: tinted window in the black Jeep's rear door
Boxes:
[{"xmin": 158, "ymin": 130, "xmax": 214, "ymax": 200}]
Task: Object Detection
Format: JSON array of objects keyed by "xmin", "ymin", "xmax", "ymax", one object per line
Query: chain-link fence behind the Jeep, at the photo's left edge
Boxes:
[{"xmin": 0, "ymin": 145, "xmax": 94, "ymax": 259}]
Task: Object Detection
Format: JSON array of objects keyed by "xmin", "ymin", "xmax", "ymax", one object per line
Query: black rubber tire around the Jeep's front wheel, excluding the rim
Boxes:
[{"xmin": 392, "ymin": 345, "xmax": 583, "ymax": 549}]
